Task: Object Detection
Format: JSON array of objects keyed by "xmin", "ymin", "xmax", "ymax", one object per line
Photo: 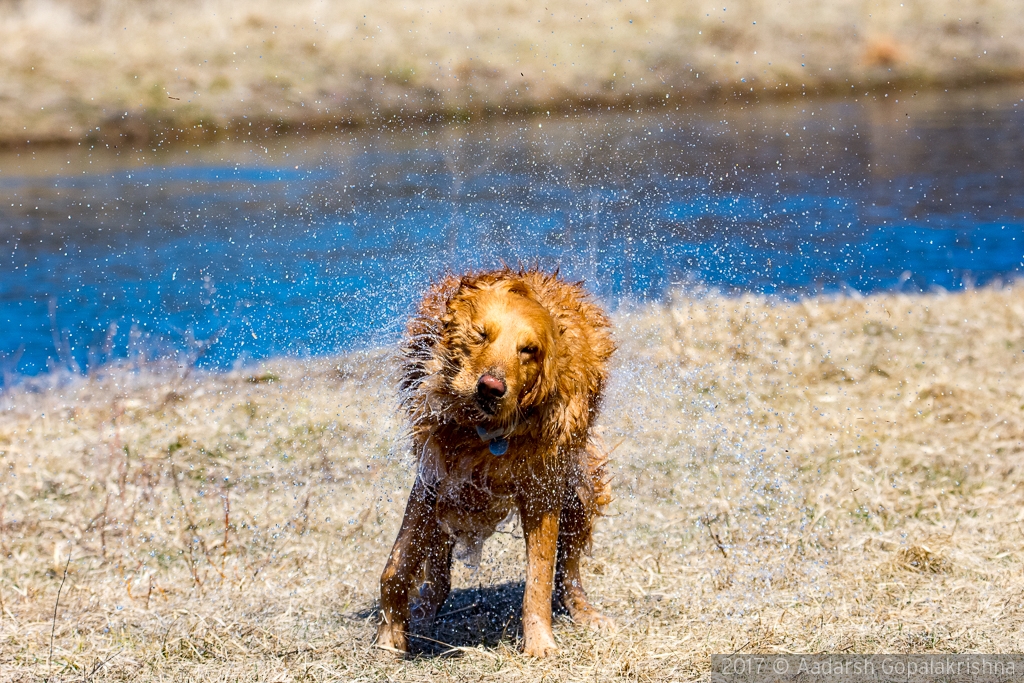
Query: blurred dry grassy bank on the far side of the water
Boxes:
[{"xmin": 0, "ymin": 0, "xmax": 1024, "ymax": 144}]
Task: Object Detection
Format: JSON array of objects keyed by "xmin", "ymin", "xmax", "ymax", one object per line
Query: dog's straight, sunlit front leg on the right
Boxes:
[{"xmin": 519, "ymin": 486, "xmax": 561, "ymax": 657}]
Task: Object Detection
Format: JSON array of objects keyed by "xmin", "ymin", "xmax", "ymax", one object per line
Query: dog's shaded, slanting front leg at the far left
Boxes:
[{"xmin": 377, "ymin": 476, "xmax": 437, "ymax": 652}]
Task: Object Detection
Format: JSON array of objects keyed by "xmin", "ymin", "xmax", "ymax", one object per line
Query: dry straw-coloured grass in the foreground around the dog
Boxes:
[{"xmin": 0, "ymin": 286, "xmax": 1024, "ymax": 681}]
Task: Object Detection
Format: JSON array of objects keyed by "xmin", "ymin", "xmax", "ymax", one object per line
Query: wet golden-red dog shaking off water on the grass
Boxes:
[{"xmin": 377, "ymin": 267, "xmax": 615, "ymax": 657}]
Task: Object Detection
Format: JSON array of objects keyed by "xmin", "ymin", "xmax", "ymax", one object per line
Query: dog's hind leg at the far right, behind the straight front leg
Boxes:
[{"xmin": 555, "ymin": 489, "xmax": 613, "ymax": 629}]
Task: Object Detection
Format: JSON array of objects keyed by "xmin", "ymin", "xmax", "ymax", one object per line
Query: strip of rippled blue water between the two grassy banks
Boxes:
[{"xmin": 0, "ymin": 89, "xmax": 1024, "ymax": 382}]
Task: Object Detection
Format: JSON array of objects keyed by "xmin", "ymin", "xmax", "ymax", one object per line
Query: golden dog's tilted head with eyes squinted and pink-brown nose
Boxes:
[{"xmin": 443, "ymin": 280, "xmax": 558, "ymax": 427}]
